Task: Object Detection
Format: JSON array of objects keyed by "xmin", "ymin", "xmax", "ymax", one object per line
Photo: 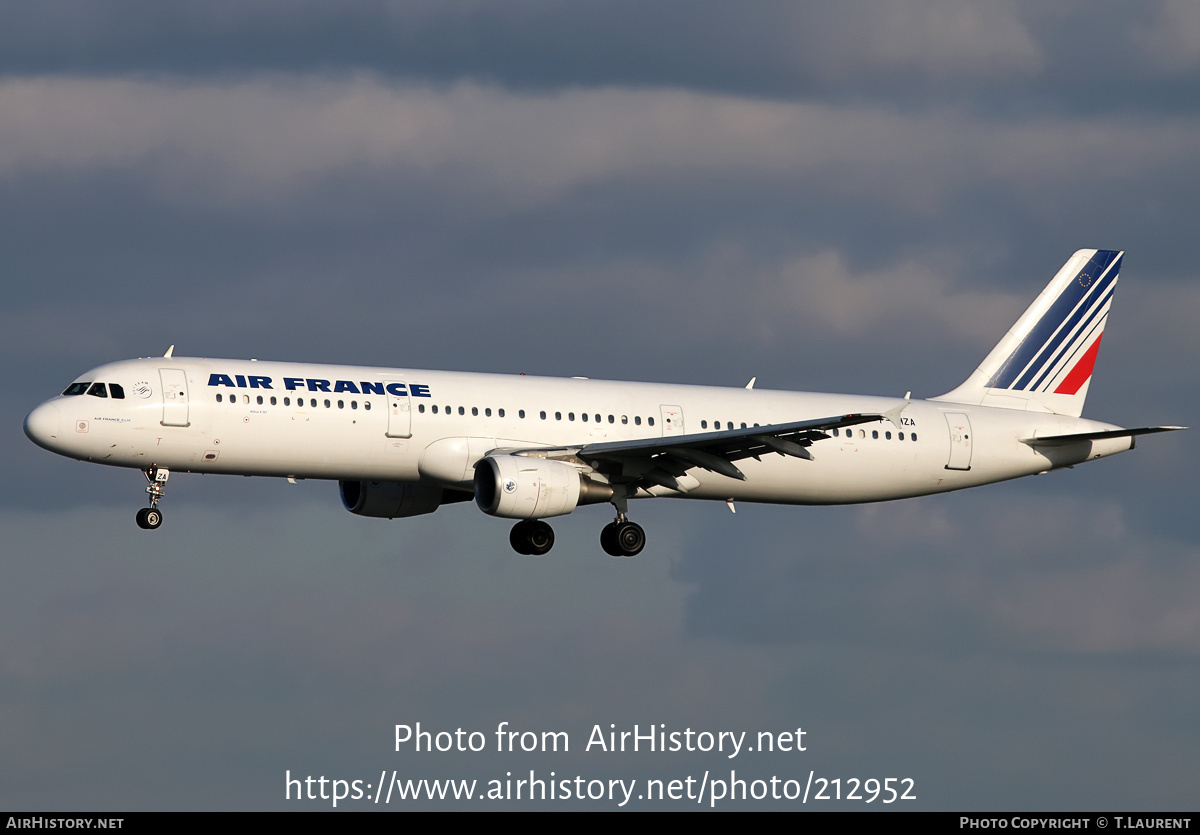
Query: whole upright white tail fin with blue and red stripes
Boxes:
[{"xmin": 932, "ymin": 250, "xmax": 1124, "ymax": 418}]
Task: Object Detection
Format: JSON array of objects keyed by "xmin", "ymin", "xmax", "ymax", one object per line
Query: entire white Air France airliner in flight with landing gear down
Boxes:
[{"xmin": 25, "ymin": 250, "xmax": 1186, "ymax": 557}]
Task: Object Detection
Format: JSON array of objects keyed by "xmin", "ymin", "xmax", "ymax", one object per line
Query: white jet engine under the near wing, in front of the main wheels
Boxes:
[{"xmin": 475, "ymin": 455, "xmax": 612, "ymax": 519}]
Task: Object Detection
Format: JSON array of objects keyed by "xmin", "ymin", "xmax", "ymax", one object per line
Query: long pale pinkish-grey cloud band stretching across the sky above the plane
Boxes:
[{"xmin": 7, "ymin": 77, "xmax": 1200, "ymax": 220}]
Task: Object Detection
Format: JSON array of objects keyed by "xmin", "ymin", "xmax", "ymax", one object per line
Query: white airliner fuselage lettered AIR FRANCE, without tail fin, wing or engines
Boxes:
[{"xmin": 26, "ymin": 358, "xmax": 1132, "ymax": 504}]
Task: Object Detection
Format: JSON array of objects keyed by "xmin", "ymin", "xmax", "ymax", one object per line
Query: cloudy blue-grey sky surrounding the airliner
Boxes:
[{"xmin": 0, "ymin": 0, "xmax": 1200, "ymax": 811}]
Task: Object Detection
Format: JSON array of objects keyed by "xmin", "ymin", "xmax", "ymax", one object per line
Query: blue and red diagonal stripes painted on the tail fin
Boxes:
[{"xmin": 986, "ymin": 250, "xmax": 1122, "ymax": 395}]
